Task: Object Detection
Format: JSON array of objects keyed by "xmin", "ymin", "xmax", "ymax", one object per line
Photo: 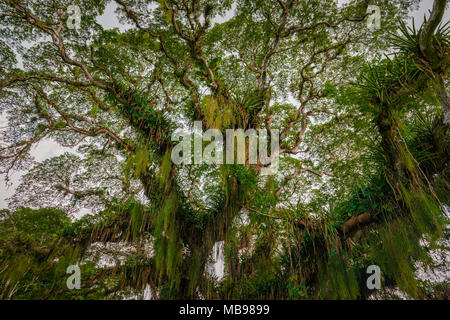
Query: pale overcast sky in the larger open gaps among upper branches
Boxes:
[{"xmin": 0, "ymin": 0, "xmax": 450, "ymax": 209}]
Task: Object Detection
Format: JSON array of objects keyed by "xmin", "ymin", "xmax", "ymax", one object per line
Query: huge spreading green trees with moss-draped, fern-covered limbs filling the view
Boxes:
[{"xmin": 0, "ymin": 0, "xmax": 450, "ymax": 299}]
